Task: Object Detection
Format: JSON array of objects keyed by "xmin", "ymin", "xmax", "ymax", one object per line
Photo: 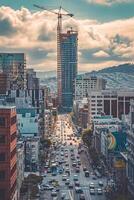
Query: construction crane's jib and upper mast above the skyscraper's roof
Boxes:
[{"xmin": 34, "ymin": 4, "xmax": 74, "ymax": 35}]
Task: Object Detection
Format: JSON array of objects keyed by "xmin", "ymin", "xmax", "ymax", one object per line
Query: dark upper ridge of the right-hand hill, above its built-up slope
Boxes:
[{"xmin": 97, "ymin": 63, "xmax": 134, "ymax": 74}]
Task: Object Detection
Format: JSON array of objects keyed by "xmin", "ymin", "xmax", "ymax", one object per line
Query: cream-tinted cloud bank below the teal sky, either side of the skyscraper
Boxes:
[{"xmin": 0, "ymin": 7, "xmax": 134, "ymax": 71}]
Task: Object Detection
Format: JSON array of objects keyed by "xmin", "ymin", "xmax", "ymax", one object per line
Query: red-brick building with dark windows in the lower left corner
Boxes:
[{"xmin": 0, "ymin": 106, "xmax": 17, "ymax": 200}]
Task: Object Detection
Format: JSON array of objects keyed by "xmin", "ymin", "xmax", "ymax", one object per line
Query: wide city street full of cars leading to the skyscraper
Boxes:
[{"xmin": 40, "ymin": 115, "xmax": 106, "ymax": 200}]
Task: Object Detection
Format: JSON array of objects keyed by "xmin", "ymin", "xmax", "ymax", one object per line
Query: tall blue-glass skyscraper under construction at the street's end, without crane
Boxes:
[{"xmin": 57, "ymin": 29, "xmax": 78, "ymax": 111}]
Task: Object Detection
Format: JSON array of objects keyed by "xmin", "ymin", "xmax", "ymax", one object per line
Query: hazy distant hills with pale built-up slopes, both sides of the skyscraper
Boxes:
[{"xmin": 37, "ymin": 63, "xmax": 134, "ymax": 90}]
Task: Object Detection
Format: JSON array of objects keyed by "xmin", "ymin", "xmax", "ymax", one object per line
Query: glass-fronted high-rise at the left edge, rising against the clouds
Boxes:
[{"xmin": 0, "ymin": 53, "xmax": 26, "ymax": 90}]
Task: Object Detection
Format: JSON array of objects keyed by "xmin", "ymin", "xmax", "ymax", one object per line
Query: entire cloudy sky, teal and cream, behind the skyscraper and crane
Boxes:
[{"xmin": 0, "ymin": 0, "xmax": 134, "ymax": 71}]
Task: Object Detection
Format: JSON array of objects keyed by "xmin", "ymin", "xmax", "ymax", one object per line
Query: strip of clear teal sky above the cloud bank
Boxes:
[{"xmin": 0, "ymin": 0, "xmax": 134, "ymax": 21}]
